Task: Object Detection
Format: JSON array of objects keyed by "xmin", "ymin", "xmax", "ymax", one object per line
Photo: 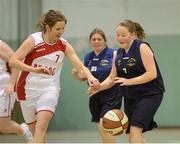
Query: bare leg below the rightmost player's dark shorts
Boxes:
[{"xmin": 129, "ymin": 126, "xmax": 145, "ymax": 143}]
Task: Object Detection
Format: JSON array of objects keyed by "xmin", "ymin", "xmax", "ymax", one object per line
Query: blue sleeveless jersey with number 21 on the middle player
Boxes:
[{"xmin": 84, "ymin": 48, "xmax": 120, "ymax": 95}]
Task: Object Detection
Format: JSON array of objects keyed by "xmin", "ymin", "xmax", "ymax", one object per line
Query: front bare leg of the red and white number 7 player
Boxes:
[{"xmin": 34, "ymin": 111, "xmax": 53, "ymax": 143}]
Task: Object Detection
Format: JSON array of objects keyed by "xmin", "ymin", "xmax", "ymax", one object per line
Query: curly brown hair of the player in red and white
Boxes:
[{"xmin": 36, "ymin": 10, "xmax": 67, "ymax": 31}]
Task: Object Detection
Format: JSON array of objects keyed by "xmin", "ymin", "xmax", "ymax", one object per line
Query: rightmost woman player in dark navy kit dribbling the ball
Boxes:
[{"xmin": 88, "ymin": 20, "xmax": 165, "ymax": 143}]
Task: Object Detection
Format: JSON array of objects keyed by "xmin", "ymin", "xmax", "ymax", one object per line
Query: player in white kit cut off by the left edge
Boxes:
[{"xmin": 0, "ymin": 40, "xmax": 32, "ymax": 142}]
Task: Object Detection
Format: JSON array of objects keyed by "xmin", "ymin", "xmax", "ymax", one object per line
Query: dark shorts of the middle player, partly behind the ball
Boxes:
[{"xmin": 89, "ymin": 86, "xmax": 122, "ymax": 122}]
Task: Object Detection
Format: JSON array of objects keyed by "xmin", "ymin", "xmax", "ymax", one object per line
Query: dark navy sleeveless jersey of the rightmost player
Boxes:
[{"xmin": 115, "ymin": 39, "xmax": 165, "ymax": 99}]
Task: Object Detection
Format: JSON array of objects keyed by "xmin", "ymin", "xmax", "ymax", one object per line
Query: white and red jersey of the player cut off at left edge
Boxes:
[{"xmin": 0, "ymin": 40, "xmax": 10, "ymax": 93}]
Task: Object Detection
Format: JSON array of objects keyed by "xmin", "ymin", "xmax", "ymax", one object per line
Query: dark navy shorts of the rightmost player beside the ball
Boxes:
[{"xmin": 124, "ymin": 94, "xmax": 163, "ymax": 133}]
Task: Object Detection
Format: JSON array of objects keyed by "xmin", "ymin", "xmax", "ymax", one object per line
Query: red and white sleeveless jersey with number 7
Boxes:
[{"xmin": 17, "ymin": 32, "xmax": 67, "ymax": 100}]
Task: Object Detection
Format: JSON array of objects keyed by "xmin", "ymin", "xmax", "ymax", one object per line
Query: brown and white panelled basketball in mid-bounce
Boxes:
[{"xmin": 102, "ymin": 109, "xmax": 128, "ymax": 135}]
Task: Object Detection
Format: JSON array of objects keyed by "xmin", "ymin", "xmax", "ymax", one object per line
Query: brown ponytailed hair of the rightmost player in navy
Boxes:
[{"xmin": 118, "ymin": 19, "xmax": 146, "ymax": 40}]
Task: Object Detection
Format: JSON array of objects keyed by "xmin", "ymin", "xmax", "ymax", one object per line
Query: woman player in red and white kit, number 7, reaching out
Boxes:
[{"xmin": 9, "ymin": 10, "xmax": 99, "ymax": 143}]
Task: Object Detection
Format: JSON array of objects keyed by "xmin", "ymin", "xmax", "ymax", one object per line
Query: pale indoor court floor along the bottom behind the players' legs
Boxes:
[{"xmin": 0, "ymin": 128, "xmax": 180, "ymax": 144}]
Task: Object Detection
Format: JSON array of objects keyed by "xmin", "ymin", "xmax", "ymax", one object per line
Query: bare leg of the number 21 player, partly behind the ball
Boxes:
[{"xmin": 97, "ymin": 119, "xmax": 116, "ymax": 143}]
